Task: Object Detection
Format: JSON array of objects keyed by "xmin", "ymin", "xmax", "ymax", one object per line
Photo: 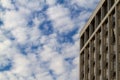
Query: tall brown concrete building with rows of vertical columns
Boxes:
[{"xmin": 80, "ymin": 0, "xmax": 120, "ymax": 80}]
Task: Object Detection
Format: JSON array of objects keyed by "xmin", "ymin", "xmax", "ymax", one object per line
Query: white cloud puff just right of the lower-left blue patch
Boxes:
[{"xmin": 11, "ymin": 53, "xmax": 30, "ymax": 76}]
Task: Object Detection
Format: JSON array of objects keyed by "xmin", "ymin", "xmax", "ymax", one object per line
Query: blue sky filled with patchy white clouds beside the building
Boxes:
[{"xmin": 0, "ymin": 0, "xmax": 99, "ymax": 80}]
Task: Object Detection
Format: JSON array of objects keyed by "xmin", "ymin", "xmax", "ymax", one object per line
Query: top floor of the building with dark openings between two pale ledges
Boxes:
[{"xmin": 80, "ymin": 0, "xmax": 120, "ymax": 48}]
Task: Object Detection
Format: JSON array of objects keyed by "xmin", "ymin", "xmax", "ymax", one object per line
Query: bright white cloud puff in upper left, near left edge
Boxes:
[{"xmin": 2, "ymin": 11, "xmax": 26, "ymax": 30}]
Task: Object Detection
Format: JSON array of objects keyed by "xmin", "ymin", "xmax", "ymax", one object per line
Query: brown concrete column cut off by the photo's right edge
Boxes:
[{"xmin": 115, "ymin": 2, "xmax": 120, "ymax": 80}]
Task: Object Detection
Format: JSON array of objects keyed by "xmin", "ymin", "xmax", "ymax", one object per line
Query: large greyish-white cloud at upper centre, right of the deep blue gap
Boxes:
[{"xmin": 47, "ymin": 5, "xmax": 74, "ymax": 33}]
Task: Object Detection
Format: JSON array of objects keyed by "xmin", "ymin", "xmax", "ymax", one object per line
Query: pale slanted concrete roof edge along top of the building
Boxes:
[{"xmin": 80, "ymin": 0, "xmax": 105, "ymax": 37}]
